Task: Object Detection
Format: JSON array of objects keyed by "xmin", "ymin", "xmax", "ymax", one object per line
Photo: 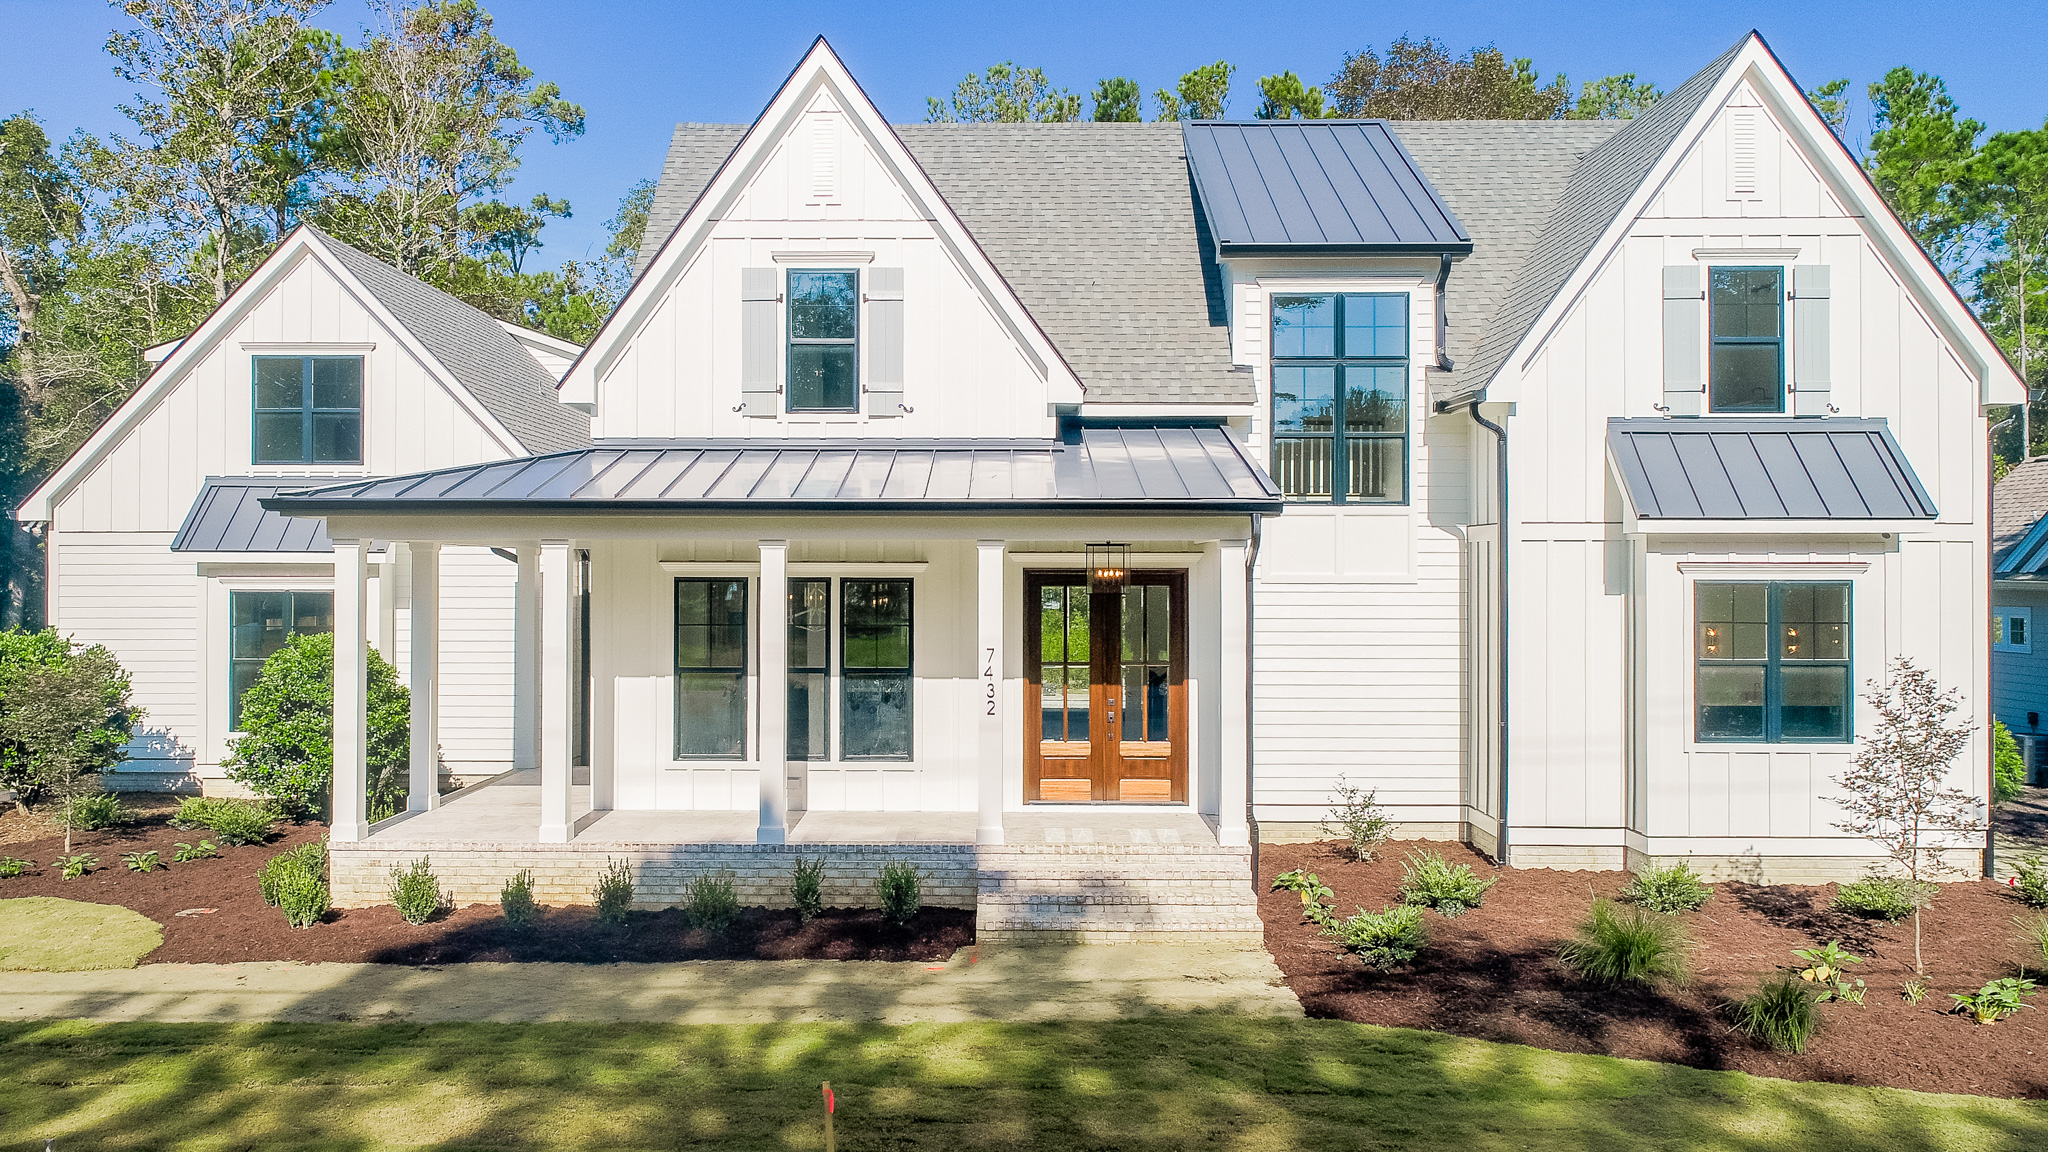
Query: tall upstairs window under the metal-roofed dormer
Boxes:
[{"xmin": 1274, "ymin": 293, "xmax": 1409, "ymax": 504}]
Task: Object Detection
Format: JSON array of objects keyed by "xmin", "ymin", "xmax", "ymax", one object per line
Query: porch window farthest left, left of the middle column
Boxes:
[{"xmin": 676, "ymin": 578, "xmax": 748, "ymax": 760}]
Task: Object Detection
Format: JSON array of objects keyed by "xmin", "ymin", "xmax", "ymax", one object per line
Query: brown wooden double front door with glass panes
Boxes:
[{"xmin": 1024, "ymin": 572, "xmax": 1188, "ymax": 804}]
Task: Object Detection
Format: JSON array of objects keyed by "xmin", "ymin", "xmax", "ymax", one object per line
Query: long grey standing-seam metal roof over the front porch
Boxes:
[{"xmin": 264, "ymin": 426, "xmax": 1282, "ymax": 515}]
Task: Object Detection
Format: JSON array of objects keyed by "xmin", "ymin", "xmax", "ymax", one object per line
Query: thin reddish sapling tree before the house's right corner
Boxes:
[{"xmin": 1835, "ymin": 658, "xmax": 1985, "ymax": 976}]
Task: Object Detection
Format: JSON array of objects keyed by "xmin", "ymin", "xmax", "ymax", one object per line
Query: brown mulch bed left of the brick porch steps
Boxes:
[{"xmin": 0, "ymin": 812, "xmax": 975, "ymax": 963}]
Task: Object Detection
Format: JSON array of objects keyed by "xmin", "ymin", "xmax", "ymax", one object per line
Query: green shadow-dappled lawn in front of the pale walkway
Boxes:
[{"xmin": 0, "ymin": 1017, "xmax": 2048, "ymax": 1152}]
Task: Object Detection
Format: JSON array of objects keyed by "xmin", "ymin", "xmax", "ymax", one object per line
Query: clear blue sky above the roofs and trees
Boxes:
[{"xmin": 0, "ymin": 0, "xmax": 2048, "ymax": 262}]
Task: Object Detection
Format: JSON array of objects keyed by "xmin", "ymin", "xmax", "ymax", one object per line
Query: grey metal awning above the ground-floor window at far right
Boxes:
[{"xmin": 1608, "ymin": 416, "xmax": 1935, "ymax": 521}]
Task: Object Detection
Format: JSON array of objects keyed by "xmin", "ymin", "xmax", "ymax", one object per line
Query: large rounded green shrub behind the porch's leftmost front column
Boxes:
[{"xmin": 221, "ymin": 633, "xmax": 412, "ymax": 816}]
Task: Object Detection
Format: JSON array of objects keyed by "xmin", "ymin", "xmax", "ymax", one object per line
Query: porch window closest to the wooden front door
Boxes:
[{"xmin": 840, "ymin": 580, "xmax": 911, "ymax": 760}]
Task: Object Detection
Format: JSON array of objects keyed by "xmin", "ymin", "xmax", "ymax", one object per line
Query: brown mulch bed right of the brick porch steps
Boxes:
[{"xmin": 1260, "ymin": 842, "xmax": 2048, "ymax": 1099}]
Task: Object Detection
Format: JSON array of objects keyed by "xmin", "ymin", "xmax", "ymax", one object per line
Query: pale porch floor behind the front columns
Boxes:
[{"xmin": 371, "ymin": 771, "xmax": 1217, "ymax": 847}]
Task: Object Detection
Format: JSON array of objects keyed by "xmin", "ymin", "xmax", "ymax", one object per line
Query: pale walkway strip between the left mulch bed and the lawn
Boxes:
[{"xmin": 0, "ymin": 943, "xmax": 1303, "ymax": 1025}]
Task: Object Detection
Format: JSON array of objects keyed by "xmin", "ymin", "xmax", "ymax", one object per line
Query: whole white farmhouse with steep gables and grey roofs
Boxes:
[{"xmin": 20, "ymin": 35, "xmax": 2021, "ymax": 922}]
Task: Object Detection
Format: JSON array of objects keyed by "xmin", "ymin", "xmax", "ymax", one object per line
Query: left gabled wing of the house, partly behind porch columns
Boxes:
[{"xmin": 18, "ymin": 228, "xmax": 590, "ymax": 791}]
